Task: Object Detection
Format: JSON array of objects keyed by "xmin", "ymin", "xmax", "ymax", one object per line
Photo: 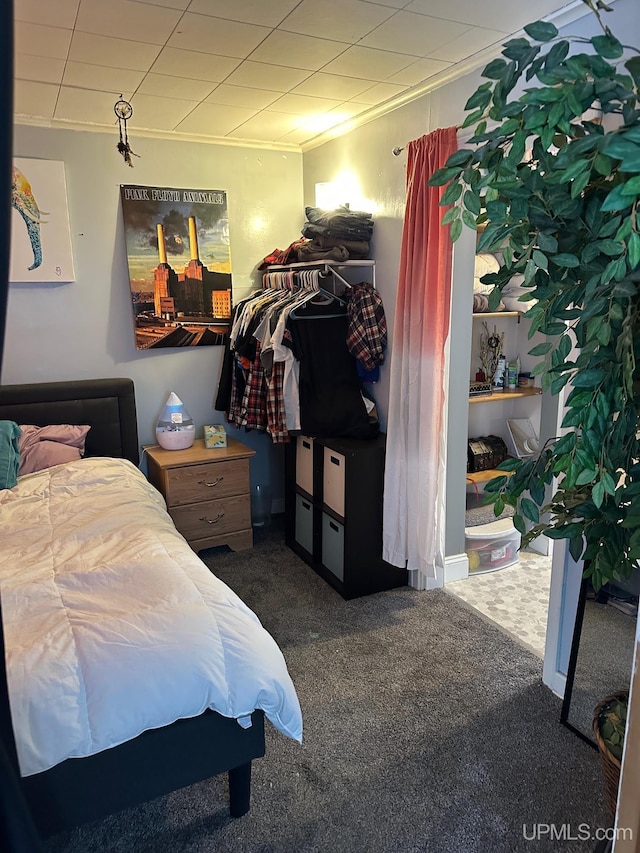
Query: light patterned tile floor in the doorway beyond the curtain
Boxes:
[{"xmin": 445, "ymin": 551, "xmax": 551, "ymax": 658}]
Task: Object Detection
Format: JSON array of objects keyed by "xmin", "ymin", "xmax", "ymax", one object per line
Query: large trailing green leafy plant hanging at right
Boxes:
[{"xmin": 430, "ymin": 0, "xmax": 640, "ymax": 588}]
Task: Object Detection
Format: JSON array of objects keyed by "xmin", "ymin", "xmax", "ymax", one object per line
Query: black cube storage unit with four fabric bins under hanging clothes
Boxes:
[{"xmin": 285, "ymin": 435, "xmax": 408, "ymax": 599}]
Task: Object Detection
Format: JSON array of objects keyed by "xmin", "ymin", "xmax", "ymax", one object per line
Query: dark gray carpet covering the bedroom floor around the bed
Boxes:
[{"xmin": 47, "ymin": 525, "xmax": 606, "ymax": 853}]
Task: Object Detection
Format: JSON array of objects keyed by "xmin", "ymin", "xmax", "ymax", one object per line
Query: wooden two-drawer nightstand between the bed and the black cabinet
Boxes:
[{"xmin": 144, "ymin": 438, "xmax": 255, "ymax": 551}]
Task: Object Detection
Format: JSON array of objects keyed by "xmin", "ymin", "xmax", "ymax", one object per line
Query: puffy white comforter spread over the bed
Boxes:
[{"xmin": 0, "ymin": 458, "xmax": 302, "ymax": 776}]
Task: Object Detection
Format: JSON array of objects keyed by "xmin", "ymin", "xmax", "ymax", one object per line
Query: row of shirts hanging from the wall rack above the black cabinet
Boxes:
[{"xmin": 215, "ymin": 269, "xmax": 387, "ymax": 443}]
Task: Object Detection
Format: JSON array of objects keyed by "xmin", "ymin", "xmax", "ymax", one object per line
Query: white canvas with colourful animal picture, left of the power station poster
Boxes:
[{"xmin": 9, "ymin": 157, "xmax": 75, "ymax": 283}]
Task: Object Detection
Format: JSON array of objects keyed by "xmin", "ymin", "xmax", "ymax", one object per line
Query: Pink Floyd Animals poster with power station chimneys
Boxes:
[{"xmin": 120, "ymin": 185, "xmax": 232, "ymax": 350}]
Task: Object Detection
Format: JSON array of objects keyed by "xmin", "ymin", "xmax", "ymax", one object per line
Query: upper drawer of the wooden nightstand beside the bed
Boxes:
[{"xmin": 165, "ymin": 459, "xmax": 250, "ymax": 506}]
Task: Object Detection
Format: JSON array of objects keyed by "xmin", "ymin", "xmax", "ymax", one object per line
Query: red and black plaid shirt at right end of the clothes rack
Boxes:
[{"xmin": 347, "ymin": 281, "xmax": 387, "ymax": 370}]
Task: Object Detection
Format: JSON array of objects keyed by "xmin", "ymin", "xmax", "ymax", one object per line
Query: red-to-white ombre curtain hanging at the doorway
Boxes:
[{"xmin": 383, "ymin": 127, "xmax": 458, "ymax": 589}]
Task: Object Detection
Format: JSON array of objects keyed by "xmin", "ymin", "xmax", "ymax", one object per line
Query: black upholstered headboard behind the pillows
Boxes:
[{"xmin": 0, "ymin": 379, "xmax": 140, "ymax": 465}]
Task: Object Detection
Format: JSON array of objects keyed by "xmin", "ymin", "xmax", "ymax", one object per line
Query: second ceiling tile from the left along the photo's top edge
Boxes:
[{"xmin": 76, "ymin": 0, "xmax": 182, "ymax": 44}]
